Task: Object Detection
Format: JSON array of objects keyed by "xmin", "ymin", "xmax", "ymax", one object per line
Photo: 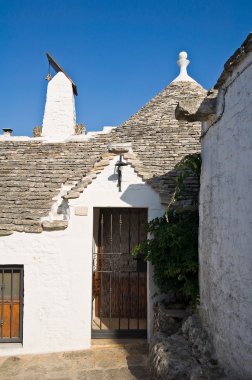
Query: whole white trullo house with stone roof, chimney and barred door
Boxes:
[{"xmin": 0, "ymin": 52, "xmax": 205, "ymax": 355}]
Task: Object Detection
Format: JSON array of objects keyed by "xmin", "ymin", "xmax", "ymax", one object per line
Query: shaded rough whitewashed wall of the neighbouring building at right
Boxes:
[{"xmin": 199, "ymin": 53, "xmax": 252, "ymax": 379}]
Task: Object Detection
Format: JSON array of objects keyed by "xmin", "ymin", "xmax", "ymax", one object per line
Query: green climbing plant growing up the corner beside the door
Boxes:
[{"xmin": 132, "ymin": 154, "xmax": 201, "ymax": 303}]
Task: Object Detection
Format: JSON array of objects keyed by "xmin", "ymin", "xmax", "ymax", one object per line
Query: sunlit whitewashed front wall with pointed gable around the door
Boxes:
[{"xmin": 0, "ymin": 157, "xmax": 164, "ymax": 355}]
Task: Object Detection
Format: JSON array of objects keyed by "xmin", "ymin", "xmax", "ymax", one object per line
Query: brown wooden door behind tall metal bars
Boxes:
[{"xmin": 93, "ymin": 208, "xmax": 147, "ymax": 336}]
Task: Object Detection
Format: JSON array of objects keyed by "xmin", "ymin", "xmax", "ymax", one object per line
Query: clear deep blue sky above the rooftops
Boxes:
[{"xmin": 0, "ymin": 0, "xmax": 252, "ymax": 136}]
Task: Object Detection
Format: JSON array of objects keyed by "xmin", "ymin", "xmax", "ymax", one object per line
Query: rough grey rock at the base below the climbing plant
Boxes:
[{"xmin": 149, "ymin": 305, "xmax": 227, "ymax": 380}]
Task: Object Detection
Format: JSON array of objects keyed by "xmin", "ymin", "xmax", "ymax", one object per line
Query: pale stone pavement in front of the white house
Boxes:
[{"xmin": 0, "ymin": 341, "xmax": 149, "ymax": 380}]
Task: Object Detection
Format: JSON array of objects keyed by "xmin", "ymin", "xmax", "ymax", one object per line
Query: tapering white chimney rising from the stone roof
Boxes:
[{"xmin": 42, "ymin": 71, "xmax": 76, "ymax": 141}]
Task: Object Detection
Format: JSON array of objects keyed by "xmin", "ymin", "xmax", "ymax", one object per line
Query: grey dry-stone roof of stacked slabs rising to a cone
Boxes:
[{"xmin": 0, "ymin": 72, "xmax": 206, "ymax": 236}]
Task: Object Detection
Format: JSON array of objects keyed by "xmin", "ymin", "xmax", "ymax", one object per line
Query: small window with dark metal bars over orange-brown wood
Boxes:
[{"xmin": 0, "ymin": 265, "xmax": 24, "ymax": 343}]
